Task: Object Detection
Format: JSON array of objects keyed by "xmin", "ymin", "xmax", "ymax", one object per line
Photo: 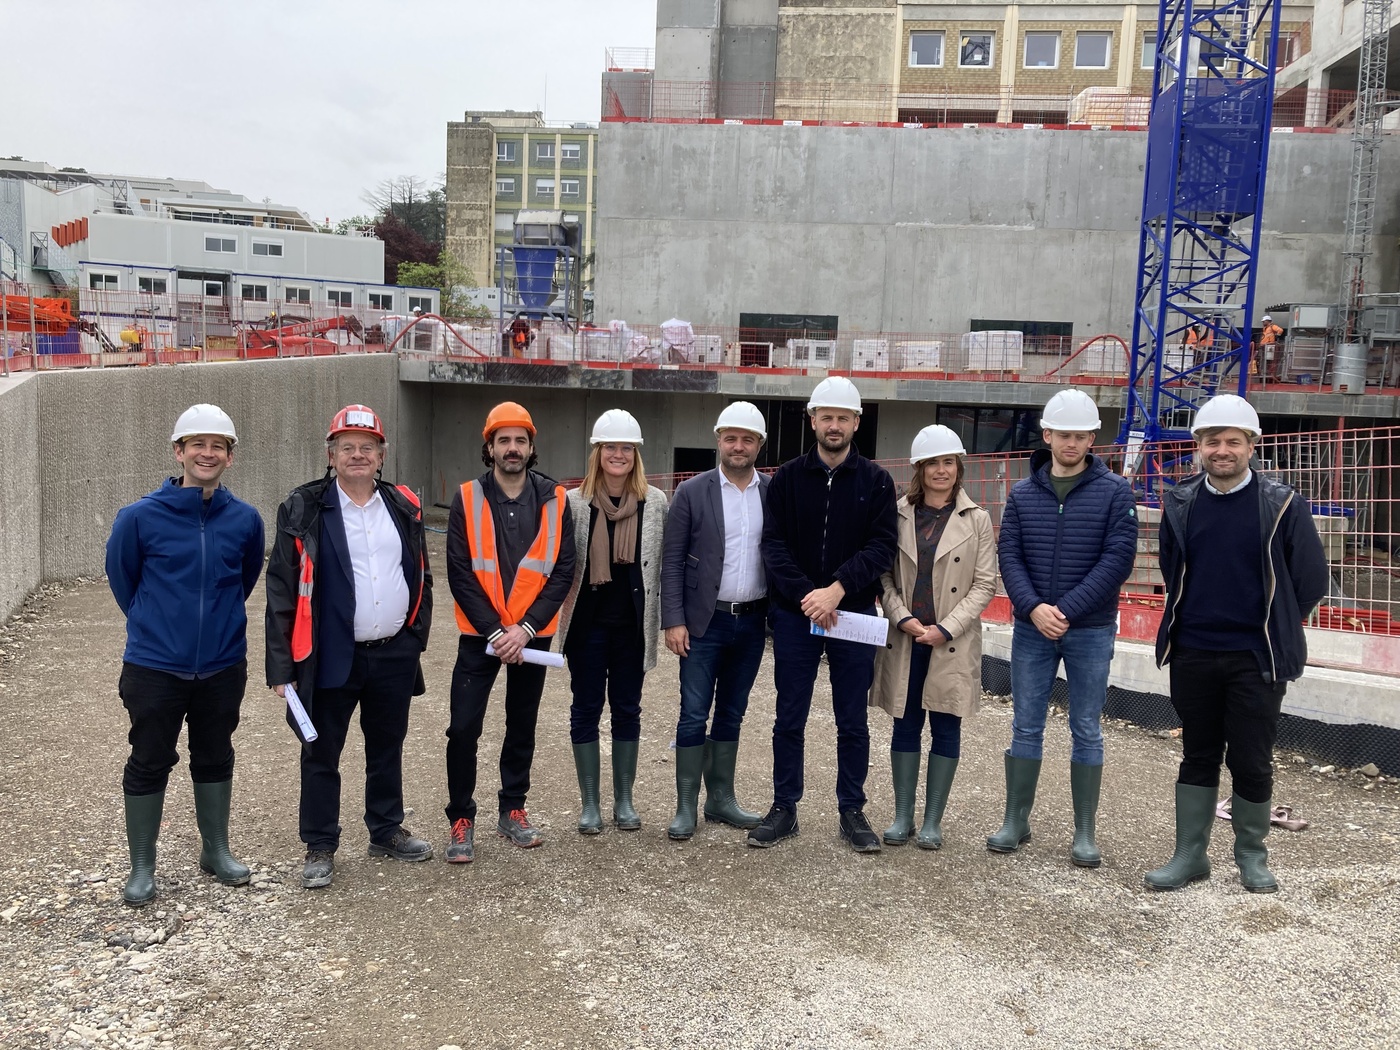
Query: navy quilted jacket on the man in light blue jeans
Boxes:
[{"xmin": 997, "ymin": 448, "xmax": 1137, "ymax": 627}]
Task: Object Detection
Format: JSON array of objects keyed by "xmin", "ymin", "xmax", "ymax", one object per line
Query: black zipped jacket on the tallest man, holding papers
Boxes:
[{"xmin": 763, "ymin": 445, "xmax": 899, "ymax": 612}]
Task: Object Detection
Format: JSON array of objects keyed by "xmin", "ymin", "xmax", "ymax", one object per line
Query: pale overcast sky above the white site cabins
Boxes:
[{"xmin": 0, "ymin": 0, "xmax": 657, "ymax": 221}]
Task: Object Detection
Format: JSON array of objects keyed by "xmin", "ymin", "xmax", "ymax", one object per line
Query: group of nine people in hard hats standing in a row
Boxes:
[{"xmin": 106, "ymin": 377, "xmax": 1327, "ymax": 906}]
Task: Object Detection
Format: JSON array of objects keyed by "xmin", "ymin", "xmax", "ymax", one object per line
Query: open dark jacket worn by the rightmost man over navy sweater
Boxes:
[{"xmin": 1156, "ymin": 472, "xmax": 1331, "ymax": 682}]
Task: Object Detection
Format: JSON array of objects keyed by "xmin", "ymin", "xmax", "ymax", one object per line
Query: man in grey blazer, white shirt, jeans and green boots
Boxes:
[{"xmin": 661, "ymin": 400, "xmax": 769, "ymax": 840}]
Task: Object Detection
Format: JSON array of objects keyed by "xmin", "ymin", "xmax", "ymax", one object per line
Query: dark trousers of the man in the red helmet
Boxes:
[{"xmin": 301, "ymin": 631, "xmax": 423, "ymax": 853}]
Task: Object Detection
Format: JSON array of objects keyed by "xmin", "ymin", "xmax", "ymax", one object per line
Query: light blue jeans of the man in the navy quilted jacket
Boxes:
[{"xmin": 1011, "ymin": 620, "xmax": 1114, "ymax": 766}]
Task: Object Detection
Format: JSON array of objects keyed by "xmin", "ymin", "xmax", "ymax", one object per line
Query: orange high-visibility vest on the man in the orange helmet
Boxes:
[{"xmin": 452, "ymin": 482, "xmax": 568, "ymax": 638}]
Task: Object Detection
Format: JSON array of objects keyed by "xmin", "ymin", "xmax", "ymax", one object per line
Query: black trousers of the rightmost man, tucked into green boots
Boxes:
[{"xmin": 1168, "ymin": 648, "xmax": 1288, "ymax": 802}]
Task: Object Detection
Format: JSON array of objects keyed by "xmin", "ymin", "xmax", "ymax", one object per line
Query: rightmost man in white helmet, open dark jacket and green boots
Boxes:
[{"xmin": 1144, "ymin": 393, "xmax": 1330, "ymax": 893}]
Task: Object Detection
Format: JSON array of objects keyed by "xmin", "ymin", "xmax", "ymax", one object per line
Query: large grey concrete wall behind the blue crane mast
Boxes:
[{"xmin": 595, "ymin": 123, "xmax": 1400, "ymax": 337}]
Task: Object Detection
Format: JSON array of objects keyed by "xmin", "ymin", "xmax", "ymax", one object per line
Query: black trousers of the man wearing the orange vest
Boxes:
[{"xmin": 447, "ymin": 634, "xmax": 553, "ymax": 822}]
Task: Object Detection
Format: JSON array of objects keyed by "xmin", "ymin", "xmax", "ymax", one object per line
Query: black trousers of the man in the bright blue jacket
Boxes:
[{"xmin": 116, "ymin": 659, "xmax": 248, "ymax": 795}]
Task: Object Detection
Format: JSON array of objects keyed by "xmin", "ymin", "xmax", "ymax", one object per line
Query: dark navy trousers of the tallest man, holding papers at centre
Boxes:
[{"xmin": 773, "ymin": 606, "xmax": 875, "ymax": 809}]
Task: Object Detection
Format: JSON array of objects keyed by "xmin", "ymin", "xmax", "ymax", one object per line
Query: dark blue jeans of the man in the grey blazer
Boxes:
[{"xmin": 676, "ymin": 610, "xmax": 767, "ymax": 748}]
